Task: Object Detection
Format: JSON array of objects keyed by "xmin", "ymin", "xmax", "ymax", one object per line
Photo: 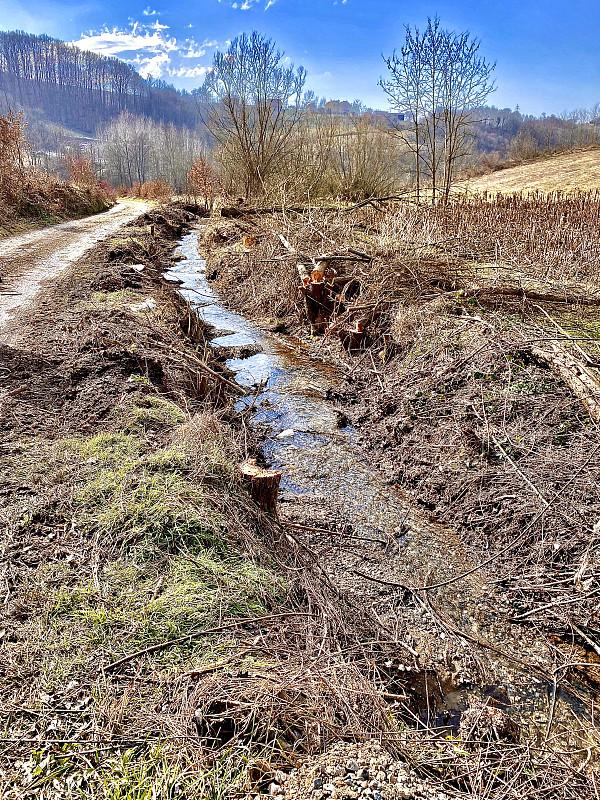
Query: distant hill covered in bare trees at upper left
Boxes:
[{"xmin": 0, "ymin": 31, "xmax": 200, "ymax": 135}]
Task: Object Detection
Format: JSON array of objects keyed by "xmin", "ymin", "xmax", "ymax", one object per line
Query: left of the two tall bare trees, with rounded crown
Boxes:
[{"xmin": 201, "ymin": 31, "xmax": 306, "ymax": 196}]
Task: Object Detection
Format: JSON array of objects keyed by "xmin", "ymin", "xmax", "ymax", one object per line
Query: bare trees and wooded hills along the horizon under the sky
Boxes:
[{"xmin": 5, "ymin": 25, "xmax": 600, "ymax": 199}]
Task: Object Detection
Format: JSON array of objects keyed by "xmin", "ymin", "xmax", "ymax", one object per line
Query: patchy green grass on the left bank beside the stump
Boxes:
[{"xmin": 7, "ymin": 404, "xmax": 286, "ymax": 800}]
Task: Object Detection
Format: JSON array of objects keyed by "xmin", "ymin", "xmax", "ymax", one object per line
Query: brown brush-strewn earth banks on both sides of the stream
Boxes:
[{"xmin": 0, "ymin": 206, "xmax": 600, "ymax": 800}]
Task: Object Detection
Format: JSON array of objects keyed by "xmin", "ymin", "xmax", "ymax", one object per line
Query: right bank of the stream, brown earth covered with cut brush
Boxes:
[{"xmin": 199, "ymin": 203, "xmax": 600, "ymax": 792}]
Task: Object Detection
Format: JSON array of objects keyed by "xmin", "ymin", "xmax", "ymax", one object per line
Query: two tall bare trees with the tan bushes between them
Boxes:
[{"xmin": 190, "ymin": 25, "xmax": 494, "ymax": 199}]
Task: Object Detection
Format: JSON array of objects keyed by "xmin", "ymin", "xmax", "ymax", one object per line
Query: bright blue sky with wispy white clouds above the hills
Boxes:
[{"xmin": 0, "ymin": 0, "xmax": 600, "ymax": 114}]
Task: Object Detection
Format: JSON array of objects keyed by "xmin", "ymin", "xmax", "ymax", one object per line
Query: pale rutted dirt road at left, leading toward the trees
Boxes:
[{"xmin": 0, "ymin": 201, "xmax": 148, "ymax": 343}]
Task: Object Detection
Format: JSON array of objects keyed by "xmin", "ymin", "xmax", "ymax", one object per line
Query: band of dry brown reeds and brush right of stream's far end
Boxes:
[{"xmin": 206, "ymin": 190, "xmax": 600, "ymax": 332}]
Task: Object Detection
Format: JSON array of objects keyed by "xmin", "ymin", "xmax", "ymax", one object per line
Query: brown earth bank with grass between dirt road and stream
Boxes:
[{"xmin": 0, "ymin": 205, "xmax": 288, "ymax": 798}]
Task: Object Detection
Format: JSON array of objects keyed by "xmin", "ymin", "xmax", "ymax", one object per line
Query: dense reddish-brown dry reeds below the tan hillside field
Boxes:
[{"xmin": 374, "ymin": 189, "xmax": 600, "ymax": 287}]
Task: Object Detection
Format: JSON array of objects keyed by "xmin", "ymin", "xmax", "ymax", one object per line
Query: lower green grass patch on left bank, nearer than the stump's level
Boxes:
[{"xmin": 42, "ymin": 550, "xmax": 283, "ymax": 668}]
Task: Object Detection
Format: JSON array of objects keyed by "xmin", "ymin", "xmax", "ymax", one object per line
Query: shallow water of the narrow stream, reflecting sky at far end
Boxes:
[{"xmin": 165, "ymin": 233, "xmax": 582, "ymax": 741}]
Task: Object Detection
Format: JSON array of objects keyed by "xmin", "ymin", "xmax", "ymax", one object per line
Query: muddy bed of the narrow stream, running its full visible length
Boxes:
[{"xmin": 165, "ymin": 233, "xmax": 586, "ymax": 745}]
